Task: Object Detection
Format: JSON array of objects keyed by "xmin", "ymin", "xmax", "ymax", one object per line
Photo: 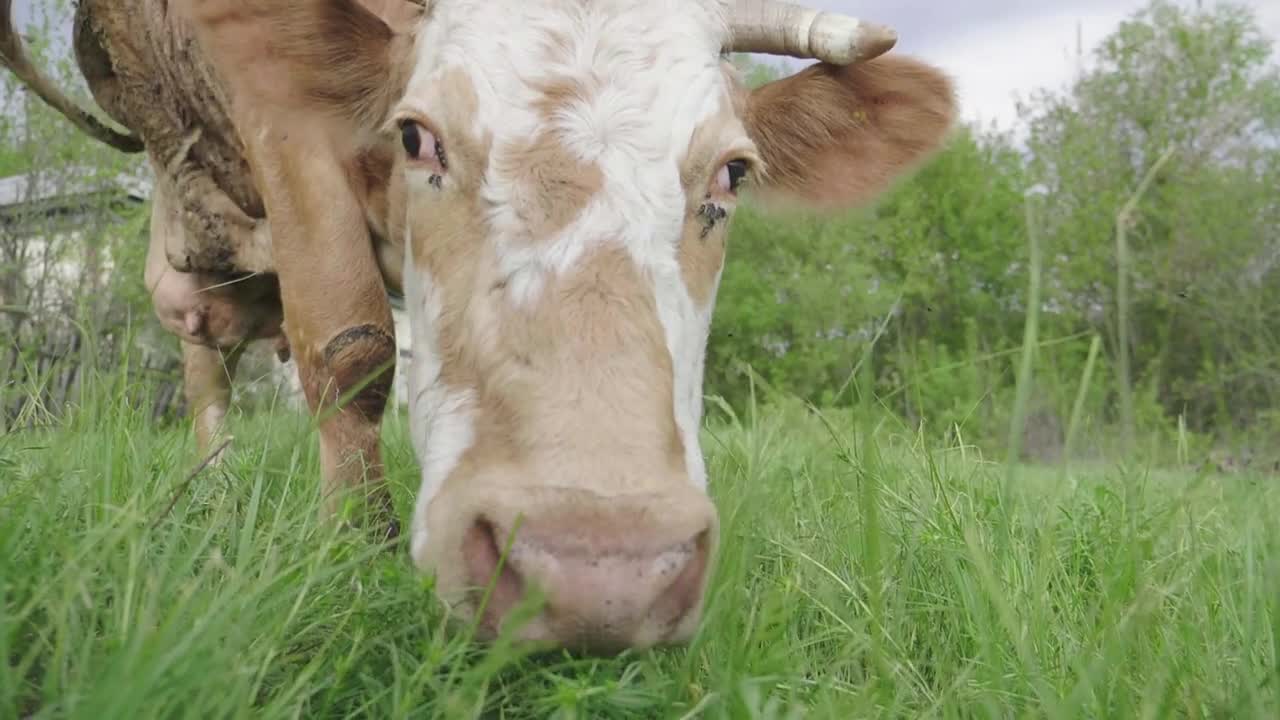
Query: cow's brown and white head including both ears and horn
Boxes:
[{"xmin": 186, "ymin": 0, "xmax": 954, "ymax": 650}]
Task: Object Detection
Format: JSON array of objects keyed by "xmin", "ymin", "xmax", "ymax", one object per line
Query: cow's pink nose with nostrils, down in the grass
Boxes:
[{"xmin": 462, "ymin": 491, "xmax": 714, "ymax": 653}]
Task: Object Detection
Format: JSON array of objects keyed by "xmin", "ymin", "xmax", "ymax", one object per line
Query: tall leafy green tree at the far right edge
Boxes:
[{"xmin": 1023, "ymin": 0, "xmax": 1280, "ymax": 429}]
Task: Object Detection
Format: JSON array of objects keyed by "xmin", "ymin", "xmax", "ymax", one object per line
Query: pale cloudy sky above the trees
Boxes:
[{"xmin": 15, "ymin": 0, "xmax": 1280, "ymax": 128}]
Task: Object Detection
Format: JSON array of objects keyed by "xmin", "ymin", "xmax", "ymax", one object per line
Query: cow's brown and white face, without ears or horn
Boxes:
[{"xmin": 394, "ymin": 0, "xmax": 760, "ymax": 647}]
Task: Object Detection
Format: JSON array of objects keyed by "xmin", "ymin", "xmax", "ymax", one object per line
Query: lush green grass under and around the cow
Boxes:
[{"xmin": 0, "ymin": 379, "xmax": 1280, "ymax": 720}]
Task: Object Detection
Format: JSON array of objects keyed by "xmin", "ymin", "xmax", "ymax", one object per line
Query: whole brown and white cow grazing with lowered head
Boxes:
[{"xmin": 0, "ymin": 0, "xmax": 955, "ymax": 651}]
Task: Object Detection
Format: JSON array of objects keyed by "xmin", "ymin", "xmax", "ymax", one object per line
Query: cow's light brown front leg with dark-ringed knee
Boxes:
[{"xmin": 243, "ymin": 122, "xmax": 399, "ymax": 537}]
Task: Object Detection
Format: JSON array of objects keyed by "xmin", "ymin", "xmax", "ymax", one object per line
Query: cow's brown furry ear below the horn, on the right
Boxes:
[{"xmin": 745, "ymin": 55, "xmax": 956, "ymax": 210}]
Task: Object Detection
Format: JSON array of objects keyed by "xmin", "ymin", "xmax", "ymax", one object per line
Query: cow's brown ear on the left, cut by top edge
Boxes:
[{"xmin": 174, "ymin": 0, "xmax": 413, "ymax": 131}]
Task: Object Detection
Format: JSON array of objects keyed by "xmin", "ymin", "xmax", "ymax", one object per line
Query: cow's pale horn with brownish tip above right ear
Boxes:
[{"xmin": 724, "ymin": 0, "xmax": 897, "ymax": 65}]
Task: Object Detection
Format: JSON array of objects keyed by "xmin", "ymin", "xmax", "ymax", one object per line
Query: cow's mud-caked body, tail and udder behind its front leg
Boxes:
[{"xmin": 0, "ymin": 0, "xmax": 421, "ymax": 466}]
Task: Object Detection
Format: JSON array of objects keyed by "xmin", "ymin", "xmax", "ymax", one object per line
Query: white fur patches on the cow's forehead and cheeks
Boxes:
[{"xmin": 404, "ymin": 0, "xmax": 731, "ymax": 555}]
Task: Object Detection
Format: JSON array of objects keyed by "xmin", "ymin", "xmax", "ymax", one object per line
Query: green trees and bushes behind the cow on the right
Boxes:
[{"xmin": 708, "ymin": 0, "xmax": 1280, "ymax": 462}]
